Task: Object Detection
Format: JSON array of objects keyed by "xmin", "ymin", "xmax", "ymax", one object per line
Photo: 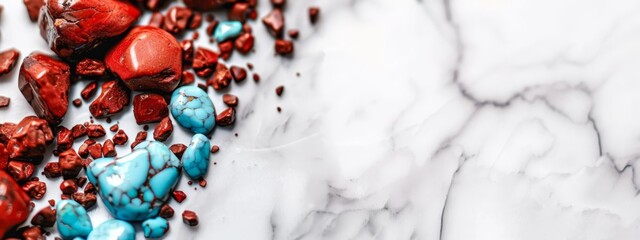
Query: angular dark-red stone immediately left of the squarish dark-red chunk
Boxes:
[{"xmin": 89, "ymin": 80, "xmax": 130, "ymax": 118}]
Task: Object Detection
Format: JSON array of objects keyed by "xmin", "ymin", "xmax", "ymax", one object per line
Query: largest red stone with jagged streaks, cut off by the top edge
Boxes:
[{"xmin": 38, "ymin": 0, "xmax": 140, "ymax": 59}]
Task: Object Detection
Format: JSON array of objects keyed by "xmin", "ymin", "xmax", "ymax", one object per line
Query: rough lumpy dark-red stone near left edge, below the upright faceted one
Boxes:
[{"xmin": 7, "ymin": 116, "xmax": 53, "ymax": 163}]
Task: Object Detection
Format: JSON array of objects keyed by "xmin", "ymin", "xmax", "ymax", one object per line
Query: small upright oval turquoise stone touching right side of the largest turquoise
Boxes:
[{"xmin": 182, "ymin": 133, "xmax": 211, "ymax": 179}]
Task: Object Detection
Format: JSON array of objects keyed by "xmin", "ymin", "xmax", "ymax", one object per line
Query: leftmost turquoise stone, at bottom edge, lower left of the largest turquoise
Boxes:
[{"xmin": 56, "ymin": 200, "xmax": 93, "ymax": 239}]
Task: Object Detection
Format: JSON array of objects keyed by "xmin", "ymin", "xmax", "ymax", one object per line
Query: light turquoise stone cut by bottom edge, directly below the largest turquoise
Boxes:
[{"xmin": 87, "ymin": 219, "xmax": 136, "ymax": 240}]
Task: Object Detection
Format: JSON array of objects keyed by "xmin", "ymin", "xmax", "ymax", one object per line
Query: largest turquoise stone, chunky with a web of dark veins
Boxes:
[{"xmin": 87, "ymin": 141, "xmax": 180, "ymax": 221}]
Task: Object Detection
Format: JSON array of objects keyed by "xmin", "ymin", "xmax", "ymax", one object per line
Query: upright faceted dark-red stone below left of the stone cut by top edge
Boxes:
[{"xmin": 18, "ymin": 52, "xmax": 70, "ymax": 126}]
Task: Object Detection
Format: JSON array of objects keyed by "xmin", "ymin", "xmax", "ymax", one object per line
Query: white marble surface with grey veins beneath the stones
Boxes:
[{"xmin": 0, "ymin": 0, "xmax": 640, "ymax": 240}]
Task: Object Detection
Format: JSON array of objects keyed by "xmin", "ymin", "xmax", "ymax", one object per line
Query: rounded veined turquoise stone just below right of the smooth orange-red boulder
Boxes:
[{"xmin": 170, "ymin": 86, "xmax": 216, "ymax": 134}]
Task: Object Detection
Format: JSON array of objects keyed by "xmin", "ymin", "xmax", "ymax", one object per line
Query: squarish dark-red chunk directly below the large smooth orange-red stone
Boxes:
[{"xmin": 133, "ymin": 93, "xmax": 169, "ymax": 125}]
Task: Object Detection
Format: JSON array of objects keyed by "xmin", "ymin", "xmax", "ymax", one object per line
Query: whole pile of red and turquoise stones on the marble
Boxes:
[{"xmin": 0, "ymin": 0, "xmax": 319, "ymax": 239}]
